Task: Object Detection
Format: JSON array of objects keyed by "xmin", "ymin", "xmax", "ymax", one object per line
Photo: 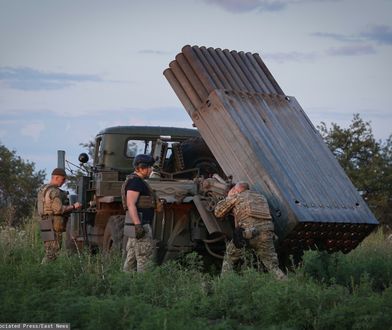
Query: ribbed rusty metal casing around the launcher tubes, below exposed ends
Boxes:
[{"xmin": 192, "ymin": 90, "xmax": 376, "ymax": 227}]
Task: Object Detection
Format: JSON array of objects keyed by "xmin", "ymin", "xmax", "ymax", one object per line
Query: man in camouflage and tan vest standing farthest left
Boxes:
[{"xmin": 37, "ymin": 168, "xmax": 82, "ymax": 264}]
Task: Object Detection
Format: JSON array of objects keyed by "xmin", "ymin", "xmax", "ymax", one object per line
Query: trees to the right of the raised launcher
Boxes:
[{"xmin": 317, "ymin": 114, "xmax": 392, "ymax": 230}]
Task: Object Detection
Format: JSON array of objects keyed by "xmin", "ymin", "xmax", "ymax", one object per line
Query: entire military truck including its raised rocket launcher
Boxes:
[{"xmin": 66, "ymin": 46, "xmax": 378, "ymax": 261}]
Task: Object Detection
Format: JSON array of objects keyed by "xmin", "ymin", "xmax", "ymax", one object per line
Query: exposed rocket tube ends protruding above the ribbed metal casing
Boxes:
[{"xmin": 164, "ymin": 45, "xmax": 284, "ymax": 113}]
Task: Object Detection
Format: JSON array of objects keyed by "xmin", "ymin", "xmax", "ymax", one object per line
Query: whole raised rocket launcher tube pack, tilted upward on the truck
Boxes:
[{"xmin": 164, "ymin": 46, "xmax": 378, "ymax": 254}]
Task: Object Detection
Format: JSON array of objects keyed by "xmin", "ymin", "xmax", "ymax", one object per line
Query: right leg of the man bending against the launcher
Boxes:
[{"xmin": 251, "ymin": 231, "xmax": 286, "ymax": 279}]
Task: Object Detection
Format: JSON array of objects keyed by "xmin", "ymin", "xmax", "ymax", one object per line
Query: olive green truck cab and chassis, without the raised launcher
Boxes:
[{"xmin": 66, "ymin": 126, "xmax": 231, "ymax": 261}]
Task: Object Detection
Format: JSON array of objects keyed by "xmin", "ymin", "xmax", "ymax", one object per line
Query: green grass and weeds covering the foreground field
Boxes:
[{"xmin": 0, "ymin": 226, "xmax": 392, "ymax": 330}]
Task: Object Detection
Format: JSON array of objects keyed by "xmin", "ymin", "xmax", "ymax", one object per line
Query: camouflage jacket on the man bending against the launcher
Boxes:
[{"xmin": 214, "ymin": 190, "xmax": 273, "ymax": 228}]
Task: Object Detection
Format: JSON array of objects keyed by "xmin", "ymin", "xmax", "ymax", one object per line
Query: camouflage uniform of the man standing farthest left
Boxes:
[{"xmin": 38, "ymin": 184, "xmax": 67, "ymax": 264}]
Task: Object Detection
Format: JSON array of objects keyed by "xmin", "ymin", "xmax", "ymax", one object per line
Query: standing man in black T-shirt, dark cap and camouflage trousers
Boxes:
[{"xmin": 122, "ymin": 154, "xmax": 155, "ymax": 272}]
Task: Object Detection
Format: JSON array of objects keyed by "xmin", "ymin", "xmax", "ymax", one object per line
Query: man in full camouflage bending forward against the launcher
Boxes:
[{"xmin": 214, "ymin": 182, "xmax": 286, "ymax": 279}]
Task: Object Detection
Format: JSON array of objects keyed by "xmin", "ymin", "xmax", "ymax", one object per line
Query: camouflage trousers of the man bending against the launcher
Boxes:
[{"xmin": 222, "ymin": 230, "xmax": 286, "ymax": 280}]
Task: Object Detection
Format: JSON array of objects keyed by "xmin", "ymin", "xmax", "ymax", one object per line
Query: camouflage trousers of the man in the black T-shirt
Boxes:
[{"xmin": 123, "ymin": 237, "xmax": 155, "ymax": 272}]
